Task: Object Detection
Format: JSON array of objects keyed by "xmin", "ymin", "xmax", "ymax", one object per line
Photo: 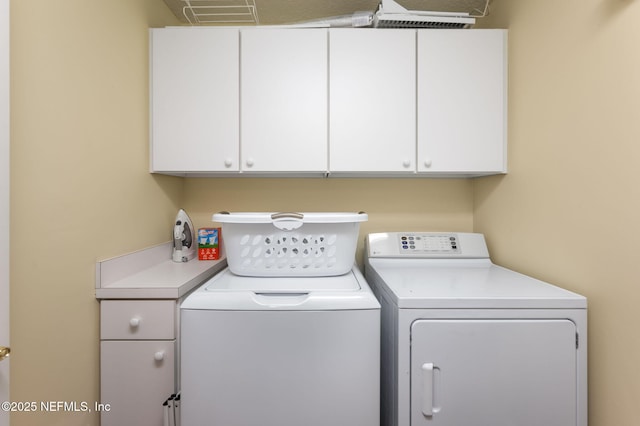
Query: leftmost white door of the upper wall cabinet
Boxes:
[{"xmin": 150, "ymin": 28, "xmax": 240, "ymax": 173}]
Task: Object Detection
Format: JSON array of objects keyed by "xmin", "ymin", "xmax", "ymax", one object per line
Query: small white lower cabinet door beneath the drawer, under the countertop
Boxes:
[{"xmin": 100, "ymin": 340, "xmax": 175, "ymax": 426}]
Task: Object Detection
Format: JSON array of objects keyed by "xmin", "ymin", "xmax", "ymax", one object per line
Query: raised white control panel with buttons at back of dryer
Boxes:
[{"xmin": 366, "ymin": 232, "xmax": 489, "ymax": 259}]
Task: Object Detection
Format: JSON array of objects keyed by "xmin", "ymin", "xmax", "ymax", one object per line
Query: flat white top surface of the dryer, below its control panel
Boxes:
[{"xmin": 367, "ymin": 258, "xmax": 587, "ymax": 309}]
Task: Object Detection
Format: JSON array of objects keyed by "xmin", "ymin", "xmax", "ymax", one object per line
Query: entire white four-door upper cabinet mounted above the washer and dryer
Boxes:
[{"xmin": 150, "ymin": 27, "xmax": 507, "ymax": 177}]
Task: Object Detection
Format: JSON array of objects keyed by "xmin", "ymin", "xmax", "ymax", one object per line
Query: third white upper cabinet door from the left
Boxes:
[{"xmin": 329, "ymin": 29, "xmax": 416, "ymax": 173}]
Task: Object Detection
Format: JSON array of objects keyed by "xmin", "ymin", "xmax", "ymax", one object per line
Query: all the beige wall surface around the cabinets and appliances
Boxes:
[{"xmin": 11, "ymin": 0, "xmax": 640, "ymax": 426}]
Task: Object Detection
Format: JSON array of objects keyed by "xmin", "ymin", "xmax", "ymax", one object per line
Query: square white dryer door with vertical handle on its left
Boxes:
[{"xmin": 411, "ymin": 319, "xmax": 577, "ymax": 426}]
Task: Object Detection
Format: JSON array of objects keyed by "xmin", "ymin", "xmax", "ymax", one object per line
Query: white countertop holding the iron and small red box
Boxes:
[{"xmin": 96, "ymin": 242, "xmax": 227, "ymax": 299}]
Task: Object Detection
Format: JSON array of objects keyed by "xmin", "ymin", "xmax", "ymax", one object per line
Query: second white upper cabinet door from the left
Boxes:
[{"xmin": 240, "ymin": 29, "xmax": 328, "ymax": 172}]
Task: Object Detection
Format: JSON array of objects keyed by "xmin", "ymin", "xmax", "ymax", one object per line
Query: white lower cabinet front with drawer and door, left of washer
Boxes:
[{"xmin": 100, "ymin": 300, "xmax": 177, "ymax": 426}]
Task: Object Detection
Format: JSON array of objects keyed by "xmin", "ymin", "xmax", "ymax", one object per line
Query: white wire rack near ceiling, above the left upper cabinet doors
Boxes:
[{"xmin": 182, "ymin": 0, "xmax": 259, "ymax": 25}]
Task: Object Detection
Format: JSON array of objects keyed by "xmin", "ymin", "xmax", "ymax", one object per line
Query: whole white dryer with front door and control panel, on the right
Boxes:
[{"xmin": 365, "ymin": 232, "xmax": 587, "ymax": 426}]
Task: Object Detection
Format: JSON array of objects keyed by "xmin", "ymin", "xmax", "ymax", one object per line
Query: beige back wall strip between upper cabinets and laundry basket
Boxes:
[{"xmin": 184, "ymin": 178, "xmax": 473, "ymax": 266}]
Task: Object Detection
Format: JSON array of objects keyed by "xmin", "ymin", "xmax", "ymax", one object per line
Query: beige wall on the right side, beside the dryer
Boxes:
[{"xmin": 474, "ymin": 0, "xmax": 640, "ymax": 426}]
